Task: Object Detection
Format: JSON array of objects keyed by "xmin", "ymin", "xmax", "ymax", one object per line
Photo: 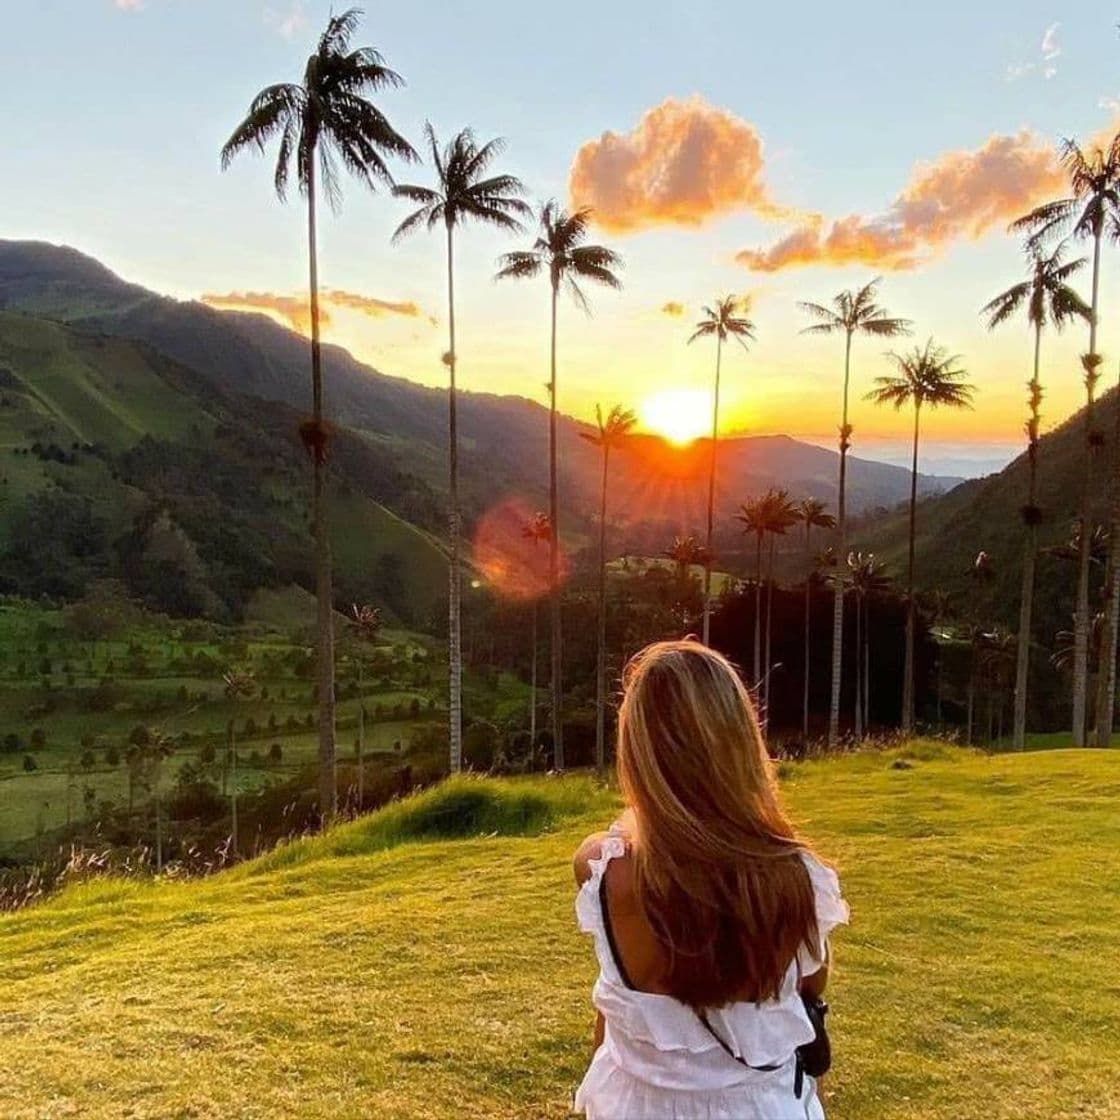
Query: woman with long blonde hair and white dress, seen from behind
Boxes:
[{"xmin": 575, "ymin": 641, "xmax": 848, "ymax": 1120}]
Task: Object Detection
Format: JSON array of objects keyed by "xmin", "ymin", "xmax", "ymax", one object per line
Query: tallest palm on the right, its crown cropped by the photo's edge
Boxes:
[{"xmin": 1011, "ymin": 136, "xmax": 1120, "ymax": 747}]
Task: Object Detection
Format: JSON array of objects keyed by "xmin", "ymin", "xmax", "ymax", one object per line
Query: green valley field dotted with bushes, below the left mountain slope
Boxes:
[{"xmin": 0, "ymin": 591, "xmax": 529, "ymax": 858}]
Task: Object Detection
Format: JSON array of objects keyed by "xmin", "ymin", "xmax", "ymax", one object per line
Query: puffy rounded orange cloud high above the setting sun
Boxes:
[{"xmin": 568, "ymin": 96, "xmax": 788, "ymax": 233}]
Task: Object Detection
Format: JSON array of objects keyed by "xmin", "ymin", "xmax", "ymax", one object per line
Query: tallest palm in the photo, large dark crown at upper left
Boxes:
[{"xmin": 222, "ymin": 8, "xmax": 416, "ymax": 820}]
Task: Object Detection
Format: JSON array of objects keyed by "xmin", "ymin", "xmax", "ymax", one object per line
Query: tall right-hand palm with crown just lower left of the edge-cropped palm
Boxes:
[{"xmin": 980, "ymin": 245, "xmax": 1092, "ymax": 750}]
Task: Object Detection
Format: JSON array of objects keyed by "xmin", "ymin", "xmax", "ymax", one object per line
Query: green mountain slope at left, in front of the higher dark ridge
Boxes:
[{"xmin": 0, "ymin": 311, "xmax": 446, "ymax": 624}]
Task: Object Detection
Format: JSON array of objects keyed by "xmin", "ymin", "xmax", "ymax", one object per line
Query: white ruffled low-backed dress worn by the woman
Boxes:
[{"xmin": 575, "ymin": 832, "xmax": 849, "ymax": 1120}]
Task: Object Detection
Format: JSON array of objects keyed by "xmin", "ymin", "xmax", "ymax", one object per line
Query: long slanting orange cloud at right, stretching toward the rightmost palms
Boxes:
[{"xmin": 736, "ymin": 129, "xmax": 1065, "ymax": 272}]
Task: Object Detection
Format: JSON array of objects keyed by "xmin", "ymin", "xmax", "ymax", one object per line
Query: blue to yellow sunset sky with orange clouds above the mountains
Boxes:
[{"xmin": 0, "ymin": 0, "xmax": 1120, "ymax": 473}]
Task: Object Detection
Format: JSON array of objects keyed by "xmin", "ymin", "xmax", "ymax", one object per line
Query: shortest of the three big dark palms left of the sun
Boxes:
[{"xmin": 497, "ymin": 200, "xmax": 622, "ymax": 769}]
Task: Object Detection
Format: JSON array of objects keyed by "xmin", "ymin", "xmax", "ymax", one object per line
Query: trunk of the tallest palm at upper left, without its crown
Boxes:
[{"xmin": 309, "ymin": 157, "xmax": 338, "ymax": 823}]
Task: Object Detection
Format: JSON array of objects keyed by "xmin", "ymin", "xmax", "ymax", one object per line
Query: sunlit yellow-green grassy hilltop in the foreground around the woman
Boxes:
[{"xmin": 0, "ymin": 744, "xmax": 1120, "ymax": 1120}]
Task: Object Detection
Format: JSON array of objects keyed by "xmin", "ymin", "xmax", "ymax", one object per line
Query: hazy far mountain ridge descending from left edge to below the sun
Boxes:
[{"xmin": 0, "ymin": 241, "xmax": 960, "ymax": 548}]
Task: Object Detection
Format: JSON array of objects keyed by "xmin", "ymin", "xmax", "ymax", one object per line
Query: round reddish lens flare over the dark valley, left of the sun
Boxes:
[{"xmin": 470, "ymin": 497, "xmax": 569, "ymax": 603}]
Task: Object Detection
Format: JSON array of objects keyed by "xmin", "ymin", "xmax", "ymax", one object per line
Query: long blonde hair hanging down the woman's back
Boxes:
[{"xmin": 618, "ymin": 641, "xmax": 818, "ymax": 1007}]
